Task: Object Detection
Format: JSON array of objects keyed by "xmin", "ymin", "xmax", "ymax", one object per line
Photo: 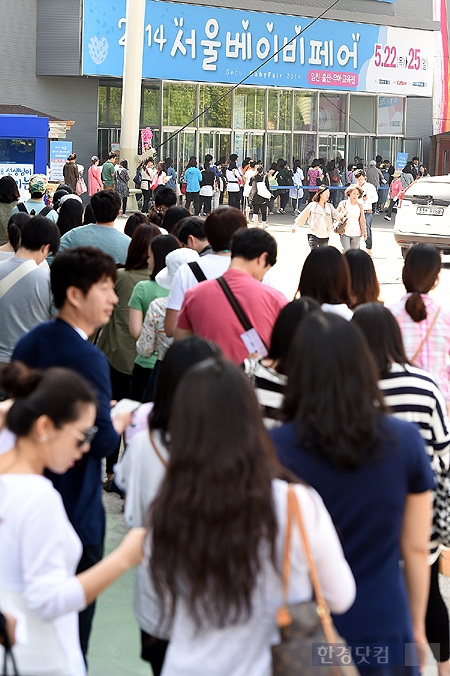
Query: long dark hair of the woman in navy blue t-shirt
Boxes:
[{"xmin": 283, "ymin": 312, "xmax": 387, "ymax": 470}]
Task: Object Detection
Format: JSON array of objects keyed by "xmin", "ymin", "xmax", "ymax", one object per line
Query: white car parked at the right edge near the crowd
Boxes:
[{"xmin": 394, "ymin": 174, "xmax": 450, "ymax": 256}]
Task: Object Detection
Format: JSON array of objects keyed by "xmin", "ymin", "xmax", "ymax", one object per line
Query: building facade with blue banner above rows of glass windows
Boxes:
[{"xmin": 0, "ymin": 0, "xmax": 440, "ymax": 177}]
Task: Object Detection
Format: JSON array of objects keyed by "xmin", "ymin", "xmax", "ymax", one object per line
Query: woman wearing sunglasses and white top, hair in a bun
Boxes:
[{"xmin": 0, "ymin": 362, "xmax": 144, "ymax": 676}]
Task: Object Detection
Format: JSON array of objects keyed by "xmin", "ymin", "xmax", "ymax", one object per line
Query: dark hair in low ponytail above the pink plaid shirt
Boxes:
[{"xmin": 402, "ymin": 244, "xmax": 442, "ymax": 322}]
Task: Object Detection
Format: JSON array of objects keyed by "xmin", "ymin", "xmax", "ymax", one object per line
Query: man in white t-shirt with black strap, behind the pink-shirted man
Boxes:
[{"xmin": 165, "ymin": 207, "xmax": 247, "ymax": 337}]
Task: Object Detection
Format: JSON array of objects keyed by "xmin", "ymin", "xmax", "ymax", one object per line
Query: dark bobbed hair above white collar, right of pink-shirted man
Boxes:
[{"xmin": 298, "ymin": 246, "xmax": 352, "ymax": 305}]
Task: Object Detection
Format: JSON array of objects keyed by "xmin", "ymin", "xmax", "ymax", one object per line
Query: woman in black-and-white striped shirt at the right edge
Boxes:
[{"xmin": 352, "ymin": 303, "xmax": 450, "ymax": 676}]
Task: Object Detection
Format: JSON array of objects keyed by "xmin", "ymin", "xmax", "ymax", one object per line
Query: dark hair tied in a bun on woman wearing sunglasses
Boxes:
[{"xmin": 0, "ymin": 361, "xmax": 97, "ymax": 438}]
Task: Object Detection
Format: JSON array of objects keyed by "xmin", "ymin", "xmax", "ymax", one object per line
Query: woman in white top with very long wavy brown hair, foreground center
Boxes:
[{"xmin": 148, "ymin": 358, "xmax": 354, "ymax": 676}]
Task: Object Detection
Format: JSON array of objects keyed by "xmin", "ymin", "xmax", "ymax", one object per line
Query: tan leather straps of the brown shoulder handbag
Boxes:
[{"xmin": 277, "ymin": 484, "xmax": 336, "ymax": 643}]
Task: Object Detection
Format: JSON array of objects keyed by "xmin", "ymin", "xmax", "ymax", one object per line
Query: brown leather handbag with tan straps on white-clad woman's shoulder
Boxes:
[{"xmin": 272, "ymin": 485, "xmax": 359, "ymax": 676}]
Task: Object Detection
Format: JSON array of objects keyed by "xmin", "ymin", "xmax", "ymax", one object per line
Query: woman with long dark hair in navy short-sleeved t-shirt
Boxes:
[{"xmin": 272, "ymin": 313, "xmax": 434, "ymax": 676}]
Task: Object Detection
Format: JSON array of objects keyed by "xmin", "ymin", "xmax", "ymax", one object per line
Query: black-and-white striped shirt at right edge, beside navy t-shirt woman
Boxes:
[{"xmin": 378, "ymin": 364, "xmax": 450, "ymax": 564}]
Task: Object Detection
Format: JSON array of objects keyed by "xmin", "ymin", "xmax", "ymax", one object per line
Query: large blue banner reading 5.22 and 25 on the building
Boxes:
[{"xmin": 82, "ymin": 0, "xmax": 434, "ymax": 96}]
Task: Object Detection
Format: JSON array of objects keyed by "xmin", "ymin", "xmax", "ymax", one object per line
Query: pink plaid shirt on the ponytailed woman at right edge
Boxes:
[{"xmin": 389, "ymin": 293, "xmax": 450, "ymax": 401}]
